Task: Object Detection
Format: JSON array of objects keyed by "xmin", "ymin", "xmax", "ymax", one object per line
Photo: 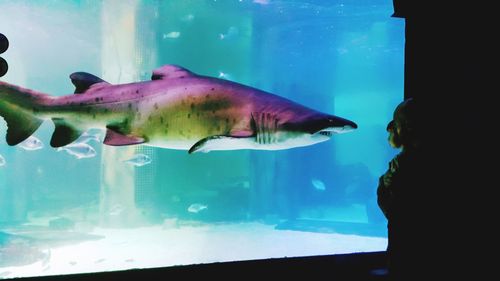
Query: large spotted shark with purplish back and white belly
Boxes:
[{"xmin": 0, "ymin": 64, "xmax": 357, "ymax": 153}]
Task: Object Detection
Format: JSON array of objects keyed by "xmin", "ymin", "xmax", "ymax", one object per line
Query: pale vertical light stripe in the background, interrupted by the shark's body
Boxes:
[{"xmin": 100, "ymin": 0, "xmax": 140, "ymax": 227}]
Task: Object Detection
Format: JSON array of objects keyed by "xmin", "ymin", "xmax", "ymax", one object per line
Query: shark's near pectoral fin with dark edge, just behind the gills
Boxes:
[{"xmin": 189, "ymin": 135, "xmax": 254, "ymax": 154}]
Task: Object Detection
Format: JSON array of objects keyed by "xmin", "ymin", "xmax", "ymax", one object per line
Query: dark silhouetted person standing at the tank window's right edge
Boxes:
[{"xmin": 377, "ymin": 99, "xmax": 425, "ymax": 280}]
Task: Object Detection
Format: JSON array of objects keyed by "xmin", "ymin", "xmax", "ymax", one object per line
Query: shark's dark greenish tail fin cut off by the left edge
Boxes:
[{"xmin": 0, "ymin": 81, "xmax": 47, "ymax": 145}]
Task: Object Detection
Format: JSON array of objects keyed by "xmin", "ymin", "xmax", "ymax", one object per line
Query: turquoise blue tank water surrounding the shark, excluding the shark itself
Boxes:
[{"xmin": 0, "ymin": 0, "xmax": 404, "ymax": 278}]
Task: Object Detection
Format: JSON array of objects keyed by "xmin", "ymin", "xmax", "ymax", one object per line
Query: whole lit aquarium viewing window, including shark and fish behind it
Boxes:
[{"xmin": 0, "ymin": 0, "xmax": 404, "ymax": 279}]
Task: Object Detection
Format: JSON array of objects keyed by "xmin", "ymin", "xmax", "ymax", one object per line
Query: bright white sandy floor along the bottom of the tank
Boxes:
[{"xmin": 0, "ymin": 219, "xmax": 387, "ymax": 279}]
